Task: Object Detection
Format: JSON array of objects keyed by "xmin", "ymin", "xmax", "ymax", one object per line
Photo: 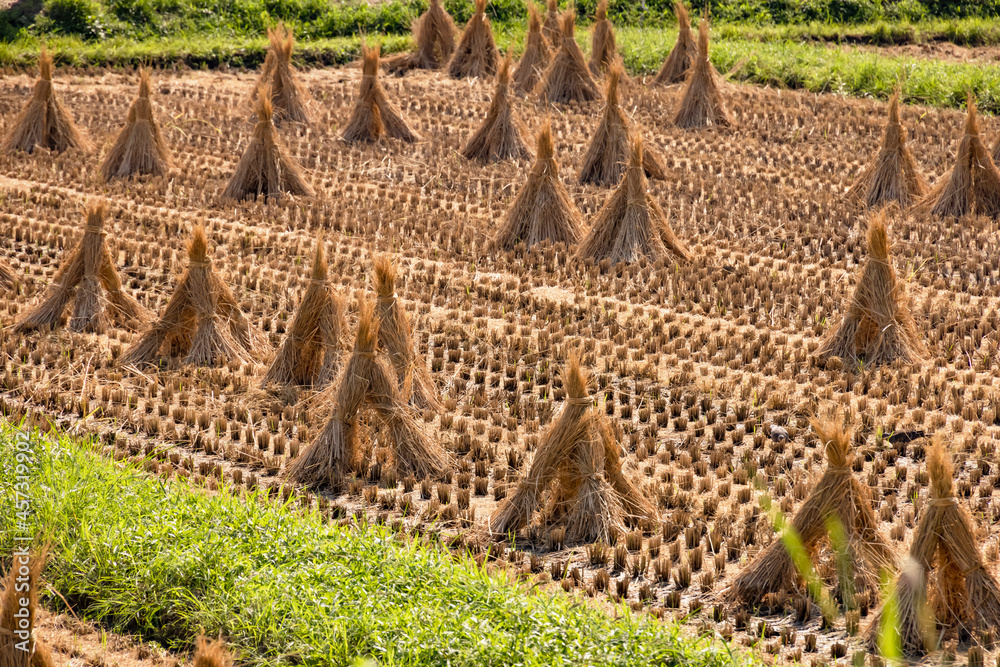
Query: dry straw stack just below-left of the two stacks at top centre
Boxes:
[{"xmin": 341, "ymin": 44, "xmax": 420, "ymax": 143}]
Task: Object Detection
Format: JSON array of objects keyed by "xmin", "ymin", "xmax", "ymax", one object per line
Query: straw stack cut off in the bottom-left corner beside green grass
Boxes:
[{"xmin": 0, "ymin": 549, "xmax": 55, "ymax": 667}]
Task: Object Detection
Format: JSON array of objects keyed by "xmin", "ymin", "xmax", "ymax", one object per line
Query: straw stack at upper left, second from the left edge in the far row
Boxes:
[{"xmin": 101, "ymin": 69, "xmax": 170, "ymax": 182}]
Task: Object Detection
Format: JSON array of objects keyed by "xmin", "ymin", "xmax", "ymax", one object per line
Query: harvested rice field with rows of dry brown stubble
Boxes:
[{"xmin": 0, "ymin": 37, "xmax": 1000, "ymax": 665}]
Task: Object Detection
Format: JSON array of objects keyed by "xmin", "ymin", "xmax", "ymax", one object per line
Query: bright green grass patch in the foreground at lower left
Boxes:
[{"xmin": 0, "ymin": 426, "xmax": 746, "ymax": 667}]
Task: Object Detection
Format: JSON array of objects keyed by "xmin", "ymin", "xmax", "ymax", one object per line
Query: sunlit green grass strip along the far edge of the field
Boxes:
[{"xmin": 0, "ymin": 24, "xmax": 1000, "ymax": 114}]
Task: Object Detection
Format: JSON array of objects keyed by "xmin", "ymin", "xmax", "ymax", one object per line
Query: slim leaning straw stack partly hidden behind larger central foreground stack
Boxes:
[{"xmin": 374, "ymin": 255, "xmax": 443, "ymax": 412}]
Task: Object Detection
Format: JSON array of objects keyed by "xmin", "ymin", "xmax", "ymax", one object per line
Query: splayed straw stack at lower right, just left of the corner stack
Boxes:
[{"xmin": 726, "ymin": 420, "xmax": 895, "ymax": 605}]
